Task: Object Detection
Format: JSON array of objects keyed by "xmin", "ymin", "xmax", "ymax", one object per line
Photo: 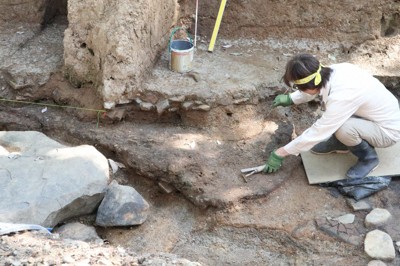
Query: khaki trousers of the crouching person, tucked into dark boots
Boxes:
[{"xmin": 335, "ymin": 117, "xmax": 396, "ymax": 148}]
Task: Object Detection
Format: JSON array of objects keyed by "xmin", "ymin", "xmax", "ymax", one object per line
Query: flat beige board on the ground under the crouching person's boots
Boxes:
[{"xmin": 301, "ymin": 143, "xmax": 400, "ymax": 184}]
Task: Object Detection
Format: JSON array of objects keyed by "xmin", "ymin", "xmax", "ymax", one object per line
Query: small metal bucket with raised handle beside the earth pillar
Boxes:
[{"xmin": 169, "ymin": 28, "xmax": 194, "ymax": 73}]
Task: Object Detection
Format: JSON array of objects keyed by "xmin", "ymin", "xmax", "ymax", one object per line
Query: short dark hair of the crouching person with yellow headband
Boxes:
[{"xmin": 282, "ymin": 54, "xmax": 332, "ymax": 91}]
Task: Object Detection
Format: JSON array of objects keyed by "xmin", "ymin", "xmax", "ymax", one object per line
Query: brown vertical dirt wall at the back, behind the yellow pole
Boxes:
[{"xmin": 180, "ymin": 0, "xmax": 400, "ymax": 44}]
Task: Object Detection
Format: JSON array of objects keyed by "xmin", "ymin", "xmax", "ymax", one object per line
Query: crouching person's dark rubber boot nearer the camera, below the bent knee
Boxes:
[{"xmin": 346, "ymin": 140, "xmax": 379, "ymax": 178}]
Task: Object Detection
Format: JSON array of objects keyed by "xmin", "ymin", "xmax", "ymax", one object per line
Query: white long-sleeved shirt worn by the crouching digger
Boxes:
[{"xmin": 284, "ymin": 63, "xmax": 400, "ymax": 155}]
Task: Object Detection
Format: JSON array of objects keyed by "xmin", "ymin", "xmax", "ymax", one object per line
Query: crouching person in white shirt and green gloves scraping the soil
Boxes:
[{"xmin": 264, "ymin": 54, "xmax": 400, "ymax": 178}]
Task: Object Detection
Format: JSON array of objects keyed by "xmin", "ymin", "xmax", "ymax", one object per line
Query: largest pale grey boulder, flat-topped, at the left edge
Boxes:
[{"xmin": 0, "ymin": 131, "xmax": 109, "ymax": 227}]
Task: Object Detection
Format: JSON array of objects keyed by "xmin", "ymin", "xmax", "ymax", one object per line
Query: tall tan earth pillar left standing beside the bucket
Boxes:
[{"xmin": 64, "ymin": 0, "xmax": 177, "ymax": 108}]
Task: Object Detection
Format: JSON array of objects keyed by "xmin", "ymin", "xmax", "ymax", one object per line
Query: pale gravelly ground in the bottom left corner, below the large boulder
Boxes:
[{"xmin": 0, "ymin": 232, "xmax": 200, "ymax": 266}]
